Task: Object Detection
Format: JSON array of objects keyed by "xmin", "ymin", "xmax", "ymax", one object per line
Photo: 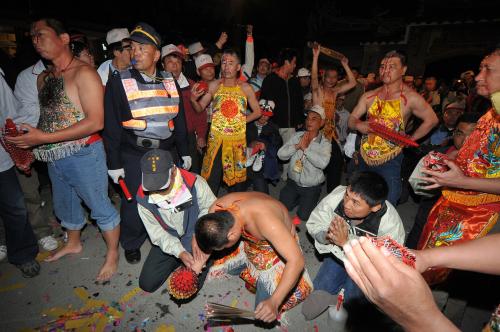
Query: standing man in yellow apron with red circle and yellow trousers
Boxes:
[{"xmin": 191, "ymin": 50, "xmax": 261, "ymax": 195}]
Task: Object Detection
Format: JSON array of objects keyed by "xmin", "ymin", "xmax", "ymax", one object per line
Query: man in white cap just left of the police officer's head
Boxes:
[{"xmin": 97, "ymin": 28, "xmax": 130, "ymax": 86}]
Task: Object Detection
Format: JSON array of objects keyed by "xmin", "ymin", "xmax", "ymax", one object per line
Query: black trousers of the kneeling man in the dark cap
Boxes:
[{"xmin": 139, "ymin": 246, "xmax": 213, "ymax": 293}]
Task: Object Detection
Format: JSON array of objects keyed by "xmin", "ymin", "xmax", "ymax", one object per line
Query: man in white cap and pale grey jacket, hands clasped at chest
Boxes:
[{"xmin": 278, "ymin": 105, "xmax": 332, "ymax": 220}]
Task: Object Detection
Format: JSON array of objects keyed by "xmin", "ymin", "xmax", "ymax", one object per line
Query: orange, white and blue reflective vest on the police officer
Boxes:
[{"xmin": 120, "ymin": 70, "xmax": 179, "ymax": 140}]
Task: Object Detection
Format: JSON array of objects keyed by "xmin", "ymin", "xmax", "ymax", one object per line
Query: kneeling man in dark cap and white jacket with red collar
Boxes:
[{"xmin": 136, "ymin": 149, "xmax": 215, "ymax": 292}]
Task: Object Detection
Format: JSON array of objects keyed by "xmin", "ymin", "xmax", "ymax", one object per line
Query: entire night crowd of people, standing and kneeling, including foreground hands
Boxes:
[{"xmin": 0, "ymin": 18, "xmax": 500, "ymax": 331}]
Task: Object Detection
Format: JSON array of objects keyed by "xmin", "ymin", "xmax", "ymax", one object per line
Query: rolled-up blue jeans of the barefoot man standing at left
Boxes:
[{"xmin": 48, "ymin": 141, "xmax": 120, "ymax": 231}]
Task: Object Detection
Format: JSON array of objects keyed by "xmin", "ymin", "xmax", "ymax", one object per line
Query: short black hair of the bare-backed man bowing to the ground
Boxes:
[{"xmin": 194, "ymin": 210, "xmax": 234, "ymax": 253}]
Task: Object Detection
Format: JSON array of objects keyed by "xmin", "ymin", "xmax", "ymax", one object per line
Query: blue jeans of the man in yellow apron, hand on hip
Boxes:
[{"xmin": 358, "ymin": 153, "xmax": 403, "ymax": 207}]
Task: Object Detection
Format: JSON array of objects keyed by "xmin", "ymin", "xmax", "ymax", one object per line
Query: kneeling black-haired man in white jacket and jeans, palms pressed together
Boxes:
[{"xmin": 302, "ymin": 172, "xmax": 405, "ymax": 319}]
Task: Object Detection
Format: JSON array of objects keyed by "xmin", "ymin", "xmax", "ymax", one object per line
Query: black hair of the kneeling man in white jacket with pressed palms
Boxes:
[{"xmin": 348, "ymin": 171, "xmax": 389, "ymax": 207}]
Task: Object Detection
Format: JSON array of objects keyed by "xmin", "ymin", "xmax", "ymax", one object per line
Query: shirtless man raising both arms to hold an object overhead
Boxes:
[{"xmin": 311, "ymin": 45, "xmax": 356, "ymax": 192}]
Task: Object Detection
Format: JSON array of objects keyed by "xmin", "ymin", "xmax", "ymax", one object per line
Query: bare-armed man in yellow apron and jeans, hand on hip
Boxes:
[{"xmin": 349, "ymin": 51, "xmax": 438, "ymax": 206}]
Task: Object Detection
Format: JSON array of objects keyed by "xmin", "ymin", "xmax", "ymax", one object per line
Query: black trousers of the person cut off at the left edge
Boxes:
[{"xmin": 0, "ymin": 167, "xmax": 38, "ymax": 264}]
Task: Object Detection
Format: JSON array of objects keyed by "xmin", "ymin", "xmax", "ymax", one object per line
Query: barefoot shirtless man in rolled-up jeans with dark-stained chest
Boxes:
[{"xmin": 10, "ymin": 18, "xmax": 120, "ymax": 280}]
